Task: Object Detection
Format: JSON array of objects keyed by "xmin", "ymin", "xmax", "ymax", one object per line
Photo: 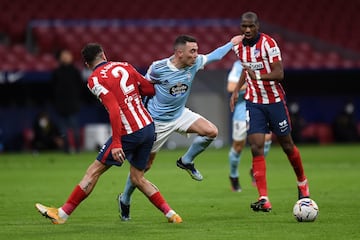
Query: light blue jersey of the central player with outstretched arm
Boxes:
[{"xmin": 145, "ymin": 42, "xmax": 233, "ymax": 122}]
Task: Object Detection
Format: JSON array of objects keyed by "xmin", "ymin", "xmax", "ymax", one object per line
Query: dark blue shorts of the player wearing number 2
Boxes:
[{"xmin": 96, "ymin": 123, "xmax": 155, "ymax": 170}]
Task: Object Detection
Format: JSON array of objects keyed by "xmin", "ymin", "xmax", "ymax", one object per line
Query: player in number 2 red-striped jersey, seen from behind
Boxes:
[{"xmin": 35, "ymin": 44, "xmax": 182, "ymax": 224}]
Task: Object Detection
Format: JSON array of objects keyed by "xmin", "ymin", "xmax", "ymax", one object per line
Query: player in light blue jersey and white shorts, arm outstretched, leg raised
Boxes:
[{"xmin": 118, "ymin": 35, "xmax": 244, "ymax": 221}]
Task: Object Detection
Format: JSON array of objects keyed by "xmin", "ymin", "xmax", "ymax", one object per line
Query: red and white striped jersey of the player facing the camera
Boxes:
[{"xmin": 233, "ymin": 33, "xmax": 285, "ymax": 104}]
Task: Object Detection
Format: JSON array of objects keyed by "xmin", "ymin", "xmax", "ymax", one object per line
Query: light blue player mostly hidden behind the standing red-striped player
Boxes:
[{"xmin": 227, "ymin": 60, "xmax": 271, "ymax": 192}]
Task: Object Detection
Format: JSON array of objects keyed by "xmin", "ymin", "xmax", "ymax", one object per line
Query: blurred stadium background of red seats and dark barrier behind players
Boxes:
[{"xmin": 0, "ymin": 0, "xmax": 360, "ymax": 151}]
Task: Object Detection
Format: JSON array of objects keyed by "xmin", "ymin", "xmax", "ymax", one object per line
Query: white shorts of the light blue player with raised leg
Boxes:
[{"xmin": 151, "ymin": 108, "xmax": 202, "ymax": 153}]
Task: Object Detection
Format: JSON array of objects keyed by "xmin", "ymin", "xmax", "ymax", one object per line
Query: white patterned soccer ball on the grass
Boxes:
[{"xmin": 293, "ymin": 198, "xmax": 319, "ymax": 222}]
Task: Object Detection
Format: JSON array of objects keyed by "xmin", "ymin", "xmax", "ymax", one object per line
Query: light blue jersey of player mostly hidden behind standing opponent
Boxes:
[{"xmin": 228, "ymin": 60, "xmax": 246, "ymax": 121}]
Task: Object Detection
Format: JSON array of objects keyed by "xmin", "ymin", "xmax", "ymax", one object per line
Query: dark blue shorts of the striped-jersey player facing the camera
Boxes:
[{"xmin": 246, "ymin": 101, "xmax": 291, "ymax": 136}]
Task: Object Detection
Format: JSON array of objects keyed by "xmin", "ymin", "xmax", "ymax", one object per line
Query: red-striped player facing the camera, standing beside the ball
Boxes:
[{"xmin": 230, "ymin": 12, "xmax": 310, "ymax": 212}]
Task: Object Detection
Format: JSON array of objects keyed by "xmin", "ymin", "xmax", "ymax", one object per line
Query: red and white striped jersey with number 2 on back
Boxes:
[{"xmin": 88, "ymin": 62, "xmax": 155, "ymax": 147}]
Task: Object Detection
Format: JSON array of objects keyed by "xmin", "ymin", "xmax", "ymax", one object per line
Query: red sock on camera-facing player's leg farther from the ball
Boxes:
[{"xmin": 252, "ymin": 156, "xmax": 268, "ymax": 196}]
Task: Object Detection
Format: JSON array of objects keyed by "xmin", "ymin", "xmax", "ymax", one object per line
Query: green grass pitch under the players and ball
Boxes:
[{"xmin": 0, "ymin": 145, "xmax": 360, "ymax": 240}]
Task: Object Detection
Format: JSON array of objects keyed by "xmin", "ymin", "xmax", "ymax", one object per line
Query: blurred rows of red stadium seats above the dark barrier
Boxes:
[{"xmin": 0, "ymin": 0, "xmax": 360, "ymax": 70}]
